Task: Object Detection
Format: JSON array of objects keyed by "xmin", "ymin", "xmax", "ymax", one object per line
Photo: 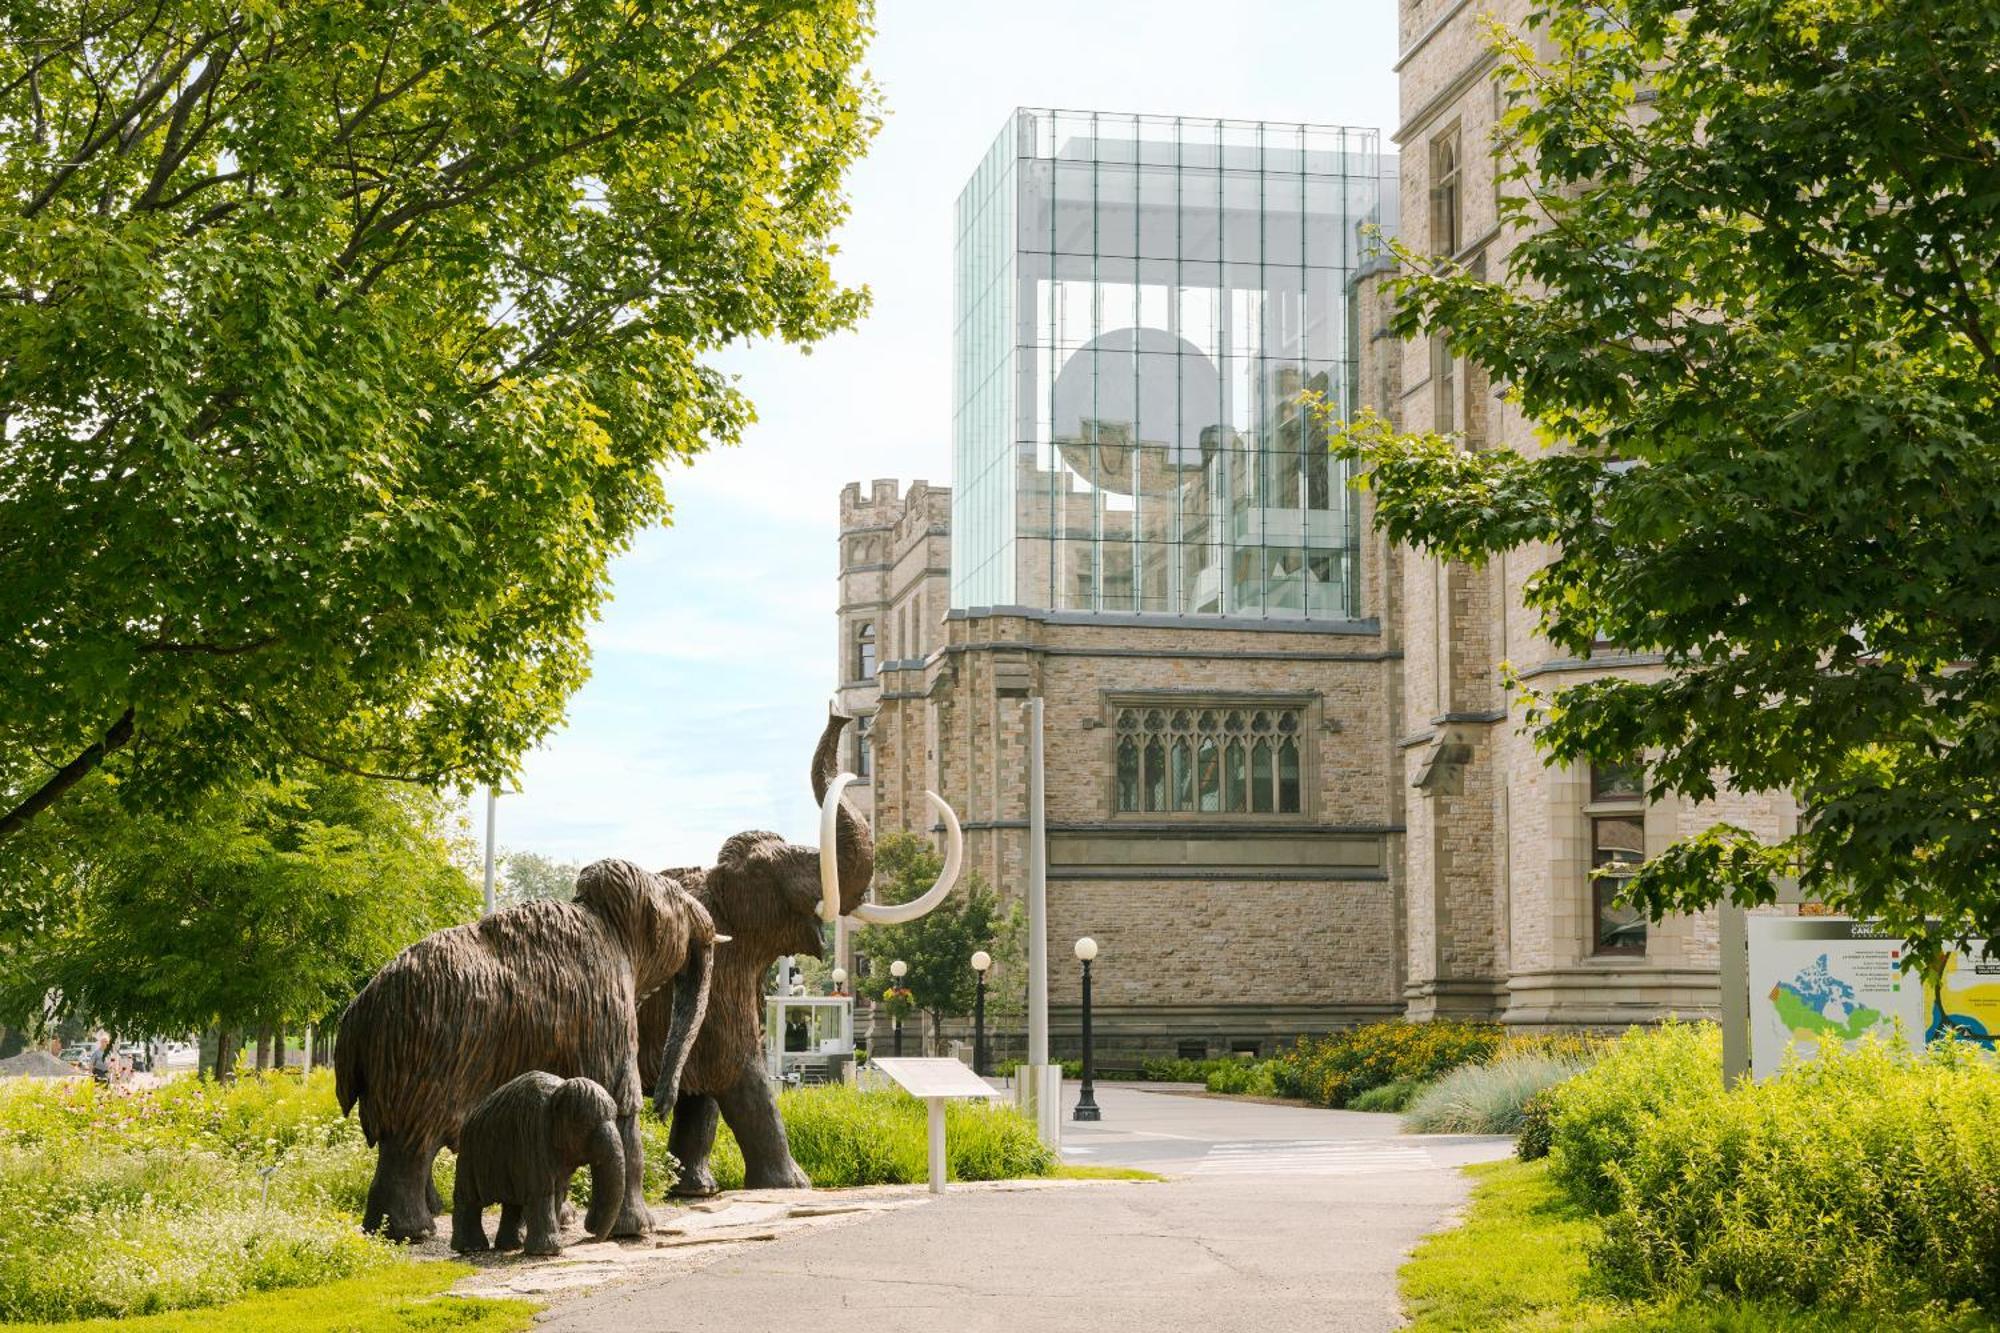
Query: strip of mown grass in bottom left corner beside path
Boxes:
[{"xmin": 6, "ymin": 1261, "xmax": 540, "ymax": 1333}]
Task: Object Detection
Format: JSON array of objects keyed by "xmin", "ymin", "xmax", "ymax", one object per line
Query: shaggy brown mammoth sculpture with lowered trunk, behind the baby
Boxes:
[{"xmin": 334, "ymin": 861, "xmax": 718, "ymax": 1241}]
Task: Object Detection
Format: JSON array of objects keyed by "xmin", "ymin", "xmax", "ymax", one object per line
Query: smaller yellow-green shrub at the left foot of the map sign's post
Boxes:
[{"xmin": 1548, "ymin": 1023, "xmax": 1722, "ymax": 1213}]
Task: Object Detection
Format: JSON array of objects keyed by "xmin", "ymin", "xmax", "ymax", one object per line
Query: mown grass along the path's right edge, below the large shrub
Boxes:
[{"xmin": 1402, "ymin": 1161, "xmax": 1996, "ymax": 1333}]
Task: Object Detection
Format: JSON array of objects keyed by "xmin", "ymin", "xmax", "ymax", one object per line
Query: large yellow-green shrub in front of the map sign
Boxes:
[{"xmin": 1584, "ymin": 1035, "xmax": 2000, "ymax": 1323}]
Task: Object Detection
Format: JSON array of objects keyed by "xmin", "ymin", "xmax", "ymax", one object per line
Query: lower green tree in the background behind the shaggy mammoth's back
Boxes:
[{"xmin": 0, "ymin": 775, "xmax": 480, "ymax": 1056}]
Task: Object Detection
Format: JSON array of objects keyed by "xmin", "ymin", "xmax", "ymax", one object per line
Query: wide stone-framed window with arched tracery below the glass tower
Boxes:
[{"xmin": 1110, "ymin": 699, "xmax": 1308, "ymax": 817}]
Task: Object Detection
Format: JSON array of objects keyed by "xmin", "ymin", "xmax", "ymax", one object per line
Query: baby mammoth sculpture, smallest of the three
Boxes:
[{"xmin": 452, "ymin": 1069, "xmax": 626, "ymax": 1255}]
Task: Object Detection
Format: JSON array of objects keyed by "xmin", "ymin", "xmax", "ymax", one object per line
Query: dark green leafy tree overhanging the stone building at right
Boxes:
[{"xmin": 1344, "ymin": 0, "xmax": 2000, "ymax": 957}]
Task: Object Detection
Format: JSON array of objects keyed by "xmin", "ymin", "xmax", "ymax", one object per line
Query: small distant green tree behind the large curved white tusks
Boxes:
[{"xmin": 854, "ymin": 833, "xmax": 1026, "ymax": 1039}]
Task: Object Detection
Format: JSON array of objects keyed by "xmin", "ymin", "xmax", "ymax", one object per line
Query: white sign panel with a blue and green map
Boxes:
[{"xmin": 1748, "ymin": 917, "xmax": 1930, "ymax": 1079}]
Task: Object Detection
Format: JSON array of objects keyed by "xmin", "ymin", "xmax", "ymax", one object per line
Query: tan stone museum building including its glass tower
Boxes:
[{"xmin": 838, "ymin": 85, "xmax": 1792, "ymax": 1057}]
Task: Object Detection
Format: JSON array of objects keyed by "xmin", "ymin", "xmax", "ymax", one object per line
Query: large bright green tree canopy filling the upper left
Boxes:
[{"xmin": 0, "ymin": 0, "xmax": 878, "ymax": 839}]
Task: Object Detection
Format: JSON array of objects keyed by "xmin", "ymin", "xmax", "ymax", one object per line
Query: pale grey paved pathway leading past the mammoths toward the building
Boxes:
[{"xmin": 542, "ymin": 1085, "xmax": 1508, "ymax": 1333}]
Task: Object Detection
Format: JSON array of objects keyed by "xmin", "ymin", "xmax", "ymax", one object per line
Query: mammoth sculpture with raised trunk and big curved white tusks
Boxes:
[{"xmin": 640, "ymin": 713, "xmax": 964, "ymax": 1197}]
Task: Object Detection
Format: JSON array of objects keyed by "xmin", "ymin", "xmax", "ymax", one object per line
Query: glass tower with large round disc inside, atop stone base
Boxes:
[{"xmin": 952, "ymin": 110, "xmax": 1396, "ymax": 620}]
